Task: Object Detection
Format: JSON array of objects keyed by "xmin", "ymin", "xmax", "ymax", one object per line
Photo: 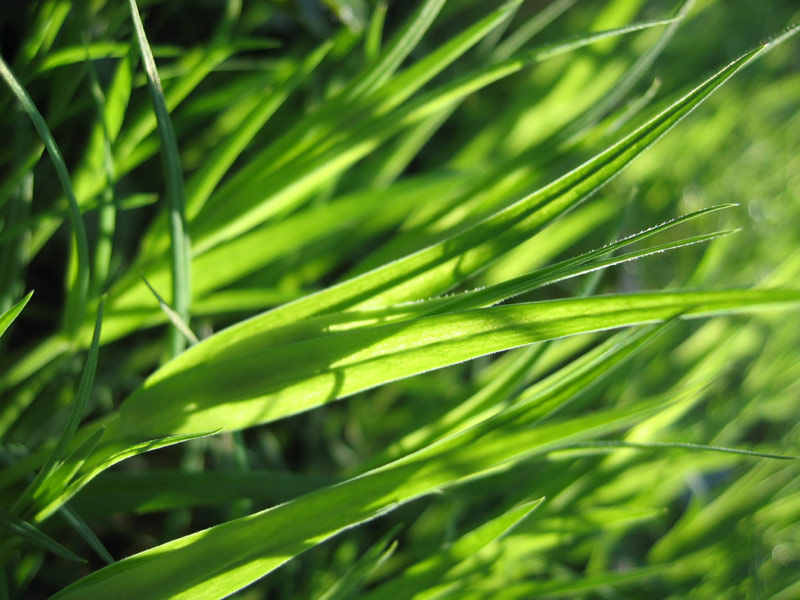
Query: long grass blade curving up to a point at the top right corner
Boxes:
[{"xmin": 156, "ymin": 27, "xmax": 798, "ymax": 378}]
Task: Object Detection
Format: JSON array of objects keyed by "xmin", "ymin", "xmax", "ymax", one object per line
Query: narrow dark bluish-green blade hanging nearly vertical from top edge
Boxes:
[{"xmin": 130, "ymin": 0, "xmax": 191, "ymax": 355}]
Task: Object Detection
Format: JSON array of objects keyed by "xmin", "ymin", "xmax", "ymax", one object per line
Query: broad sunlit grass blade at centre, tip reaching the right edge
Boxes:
[{"xmin": 115, "ymin": 290, "xmax": 800, "ymax": 440}]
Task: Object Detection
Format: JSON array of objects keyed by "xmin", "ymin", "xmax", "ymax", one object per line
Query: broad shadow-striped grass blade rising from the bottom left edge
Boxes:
[{"xmin": 54, "ymin": 394, "xmax": 661, "ymax": 600}]
